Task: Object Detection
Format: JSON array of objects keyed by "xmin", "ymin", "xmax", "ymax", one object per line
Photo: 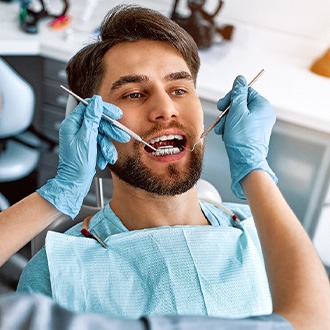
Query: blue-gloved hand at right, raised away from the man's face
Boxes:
[{"xmin": 215, "ymin": 76, "xmax": 277, "ymax": 199}]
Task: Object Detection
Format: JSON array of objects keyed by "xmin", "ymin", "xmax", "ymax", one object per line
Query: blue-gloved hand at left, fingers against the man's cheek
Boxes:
[{"xmin": 37, "ymin": 95, "xmax": 130, "ymax": 219}]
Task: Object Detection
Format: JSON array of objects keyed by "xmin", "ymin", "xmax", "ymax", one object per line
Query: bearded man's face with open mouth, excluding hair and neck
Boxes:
[{"xmin": 99, "ymin": 40, "xmax": 204, "ymax": 195}]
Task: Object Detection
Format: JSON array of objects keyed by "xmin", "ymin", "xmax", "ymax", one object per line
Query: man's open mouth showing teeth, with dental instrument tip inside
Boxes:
[{"xmin": 145, "ymin": 134, "xmax": 186, "ymax": 157}]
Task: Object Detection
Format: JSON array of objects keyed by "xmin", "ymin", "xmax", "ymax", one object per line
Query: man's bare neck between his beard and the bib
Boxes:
[{"xmin": 110, "ymin": 178, "xmax": 209, "ymax": 230}]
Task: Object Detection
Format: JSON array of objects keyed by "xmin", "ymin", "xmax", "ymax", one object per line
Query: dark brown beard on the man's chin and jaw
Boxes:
[{"xmin": 108, "ymin": 126, "xmax": 204, "ymax": 196}]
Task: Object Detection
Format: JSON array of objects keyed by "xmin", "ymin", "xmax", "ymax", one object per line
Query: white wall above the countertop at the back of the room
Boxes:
[{"xmin": 84, "ymin": 0, "xmax": 330, "ymax": 44}]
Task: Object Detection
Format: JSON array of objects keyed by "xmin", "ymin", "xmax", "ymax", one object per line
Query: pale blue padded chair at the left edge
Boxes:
[{"xmin": 0, "ymin": 58, "xmax": 40, "ymax": 280}]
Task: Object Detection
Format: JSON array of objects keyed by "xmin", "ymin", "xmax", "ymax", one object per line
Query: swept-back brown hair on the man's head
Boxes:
[{"xmin": 67, "ymin": 5, "xmax": 200, "ymax": 98}]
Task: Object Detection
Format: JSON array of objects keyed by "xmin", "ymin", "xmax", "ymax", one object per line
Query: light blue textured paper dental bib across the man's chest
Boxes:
[{"xmin": 46, "ymin": 209, "xmax": 272, "ymax": 319}]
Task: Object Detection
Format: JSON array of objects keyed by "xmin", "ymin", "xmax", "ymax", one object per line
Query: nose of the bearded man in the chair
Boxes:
[{"xmin": 149, "ymin": 91, "xmax": 179, "ymax": 122}]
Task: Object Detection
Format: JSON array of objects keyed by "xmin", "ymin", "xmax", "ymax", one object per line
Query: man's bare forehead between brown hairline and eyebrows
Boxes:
[{"xmin": 104, "ymin": 40, "xmax": 191, "ymax": 80}]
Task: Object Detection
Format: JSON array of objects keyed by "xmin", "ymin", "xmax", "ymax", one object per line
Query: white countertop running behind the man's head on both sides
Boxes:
[{"xmin": 0, "ymin": 2, "xmax": 330, "ymax": 133}]
